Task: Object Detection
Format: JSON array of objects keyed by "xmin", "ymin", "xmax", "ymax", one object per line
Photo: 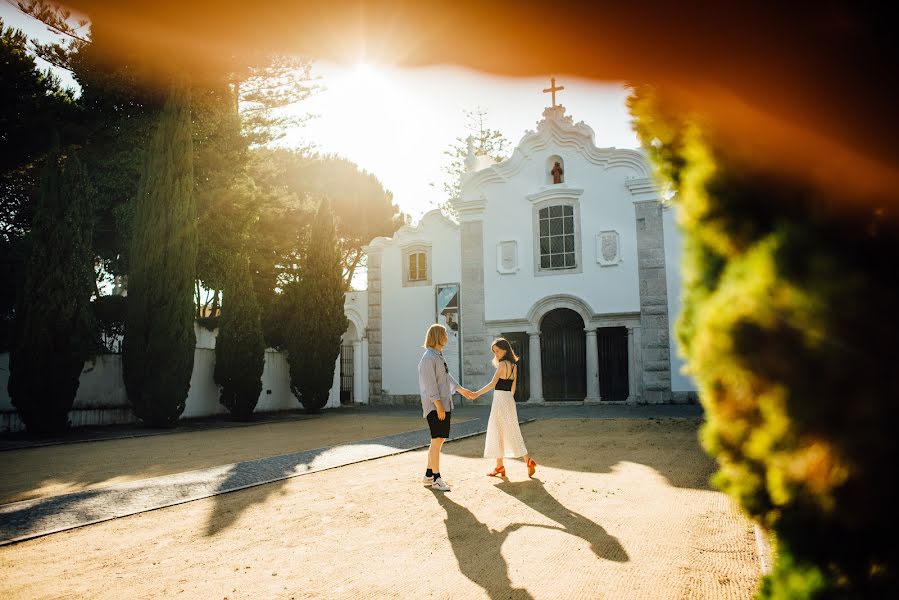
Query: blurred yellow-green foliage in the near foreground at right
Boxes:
[{"xmin": 630, "ymin": 88, "xmax": 899, "ymax": 598}]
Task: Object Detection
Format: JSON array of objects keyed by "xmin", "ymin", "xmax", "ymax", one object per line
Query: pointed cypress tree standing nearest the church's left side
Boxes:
[{"xmin": 285, "ymin": 200, "xmax": 347, "ymax": 413}]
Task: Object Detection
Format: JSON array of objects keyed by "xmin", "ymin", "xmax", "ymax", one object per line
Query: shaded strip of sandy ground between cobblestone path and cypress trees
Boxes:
[{"xmin": 0, "ymin": 412, "xmax": 434, "ymax": 504}]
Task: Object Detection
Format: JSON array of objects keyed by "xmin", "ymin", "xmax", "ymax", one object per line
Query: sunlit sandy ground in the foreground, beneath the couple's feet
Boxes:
[{"xmin": 0, "ymin": 420, "xmax": 759, "ymax": 599}]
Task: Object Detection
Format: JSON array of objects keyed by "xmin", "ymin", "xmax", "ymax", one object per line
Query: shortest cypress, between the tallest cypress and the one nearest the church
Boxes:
[{"xmin": 214, "ymin": 255, "xmax": 265, "ymax": 420}]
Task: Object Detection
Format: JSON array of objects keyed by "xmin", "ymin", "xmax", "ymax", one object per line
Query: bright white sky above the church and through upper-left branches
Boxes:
[{"xmin": 0, "ymin": 0, "xmax": 638, "ymax": 221}]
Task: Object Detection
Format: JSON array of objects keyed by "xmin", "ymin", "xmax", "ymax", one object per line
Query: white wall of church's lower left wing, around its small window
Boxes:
[{"xmin": 381, "ymin": 211, "xmax": 465, "ymax": 395}]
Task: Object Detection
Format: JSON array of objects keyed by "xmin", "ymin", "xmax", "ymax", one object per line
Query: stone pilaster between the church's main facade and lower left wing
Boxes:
[{"xmin": 460, "ymin": 218, "xmax": 490, "ymax": 385}]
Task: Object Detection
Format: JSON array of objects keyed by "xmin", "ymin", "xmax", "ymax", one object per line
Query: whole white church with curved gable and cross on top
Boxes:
[{"xmin": 341, "ymin": 79, "xmax": 696, "ymax": 405}]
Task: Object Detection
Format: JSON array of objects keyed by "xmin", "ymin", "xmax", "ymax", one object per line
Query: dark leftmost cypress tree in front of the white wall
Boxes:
[{"xmin": 7, "ymin": 150, "xmax": 94, "ymax": 433}]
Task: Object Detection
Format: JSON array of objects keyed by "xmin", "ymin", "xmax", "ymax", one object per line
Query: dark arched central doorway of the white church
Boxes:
[{"xmin": 540, "ymin": 308, "xmax": 587, "ymax": 401}]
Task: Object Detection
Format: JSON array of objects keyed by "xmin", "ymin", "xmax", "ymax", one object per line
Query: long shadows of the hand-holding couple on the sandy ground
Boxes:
[{"xmin": 434, "ymin": 479, "xmax": 629, "ymax": 600}]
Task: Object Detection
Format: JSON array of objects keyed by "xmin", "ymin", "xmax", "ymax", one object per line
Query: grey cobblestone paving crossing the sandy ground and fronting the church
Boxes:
[{"xmin": 0, "ymin": 405, "xmax": 702, "ymax": 546}]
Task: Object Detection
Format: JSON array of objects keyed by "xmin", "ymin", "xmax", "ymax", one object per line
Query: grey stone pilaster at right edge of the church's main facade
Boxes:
[{"xmin": 634, "ymin": 200, "xmax": 672, "ymax": 403}]
